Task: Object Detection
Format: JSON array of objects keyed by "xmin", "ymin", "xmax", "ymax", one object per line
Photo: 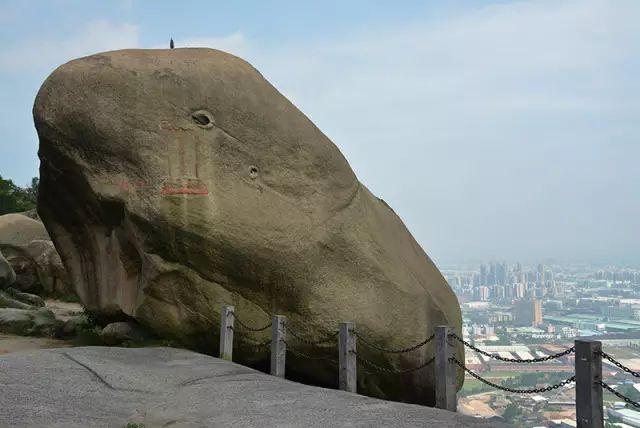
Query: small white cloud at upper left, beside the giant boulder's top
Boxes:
[{"xmin": 0, "ymin": 20, "xmax": 138, "ymax": 73}]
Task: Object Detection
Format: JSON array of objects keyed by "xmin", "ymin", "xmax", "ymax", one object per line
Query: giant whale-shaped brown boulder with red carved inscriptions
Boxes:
[{"xmin": 33, "ymin": 49, "xmax": 462, "ymax": 403}]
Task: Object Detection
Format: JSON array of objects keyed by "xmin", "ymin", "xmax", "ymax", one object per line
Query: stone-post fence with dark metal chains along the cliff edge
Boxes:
[{"xmin": 220, "ymin": 306, "xmax": 640, "ymax": 427}]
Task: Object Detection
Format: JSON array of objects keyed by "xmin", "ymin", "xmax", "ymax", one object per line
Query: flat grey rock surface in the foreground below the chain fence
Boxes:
[{"xmin": 0, "ymin": 347, "xmax": 507, "ymax": 428}]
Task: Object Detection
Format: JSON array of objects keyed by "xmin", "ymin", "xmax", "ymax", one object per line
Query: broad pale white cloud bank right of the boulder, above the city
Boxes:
[{"xmin": 232, "ymin": 0, "xmax": 640, "ymax": 259}]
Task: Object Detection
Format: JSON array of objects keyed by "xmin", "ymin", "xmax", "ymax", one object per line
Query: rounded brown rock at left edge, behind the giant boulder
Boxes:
[{"xmin": 0, "ymin": 212, "xmax": 75, "ymax": 295}]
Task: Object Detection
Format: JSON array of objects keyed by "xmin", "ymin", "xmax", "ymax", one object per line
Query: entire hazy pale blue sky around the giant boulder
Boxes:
[{"xmin": 0, "ymin": 0, "xmax": 640, "ymax": 265}]
